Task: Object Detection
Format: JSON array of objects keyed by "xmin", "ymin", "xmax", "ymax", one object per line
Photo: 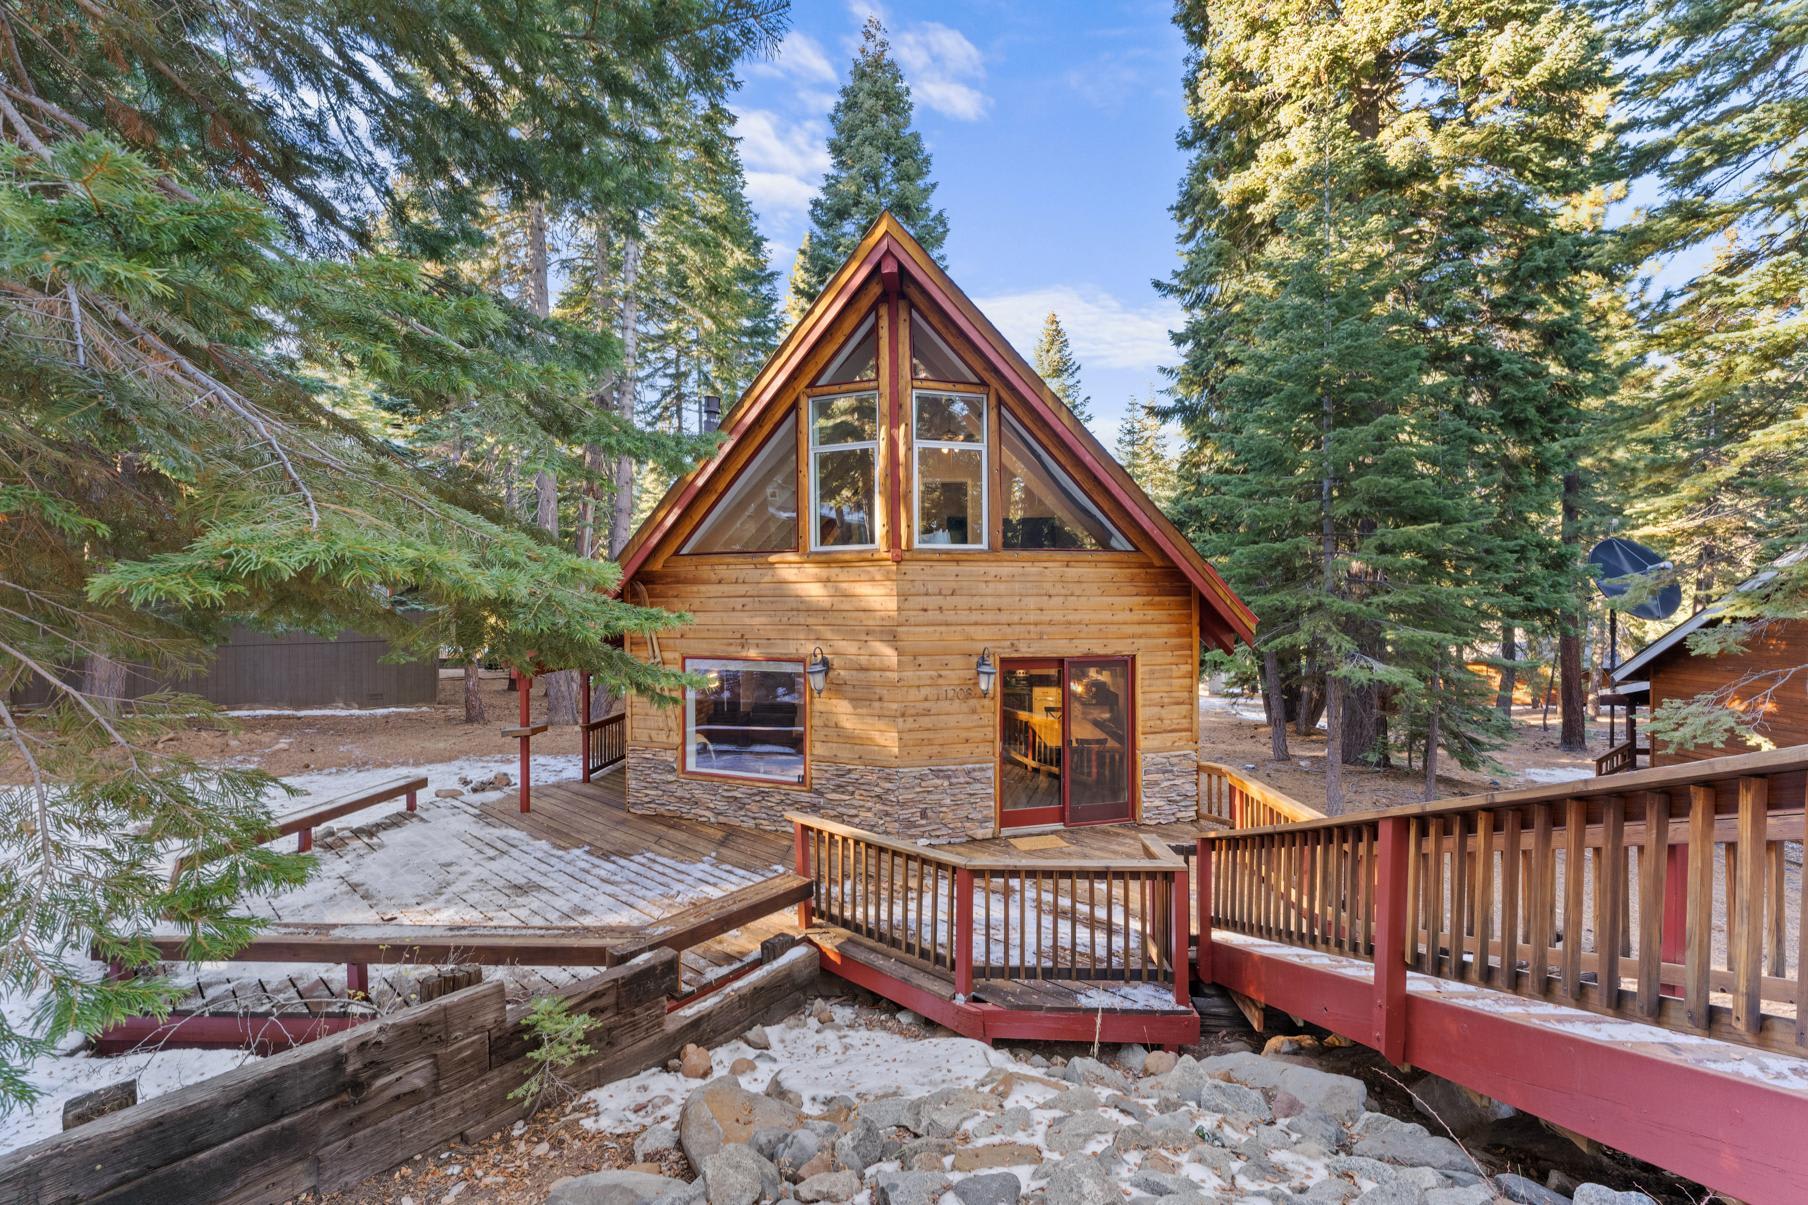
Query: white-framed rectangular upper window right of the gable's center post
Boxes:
[{"xmin": 911, "ymin": 389, "xmax": 987, "ymax": 548}]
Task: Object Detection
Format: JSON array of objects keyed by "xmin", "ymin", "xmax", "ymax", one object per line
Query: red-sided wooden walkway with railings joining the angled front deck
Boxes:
[{"xmin": 792, "ymin": 747, "xmax": 1808, "ymax": 1201}]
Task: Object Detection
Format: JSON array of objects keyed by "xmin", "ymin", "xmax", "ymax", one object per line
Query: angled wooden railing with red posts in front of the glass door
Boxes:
[{"xmin": 788, "ymin": 814, "xmax": 1188, "ymax": 1004}]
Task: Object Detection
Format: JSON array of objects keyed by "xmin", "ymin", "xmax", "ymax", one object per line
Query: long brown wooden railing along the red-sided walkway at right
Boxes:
[{"xmin": 1197, "ymin": 745, "xmax": 1808, "ymax": 1053}]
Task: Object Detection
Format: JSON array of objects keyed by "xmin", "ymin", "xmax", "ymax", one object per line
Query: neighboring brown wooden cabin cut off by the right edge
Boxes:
[{"xmin": 1596, "ymin": 552, "xmax": 1808, "ymax": 759}]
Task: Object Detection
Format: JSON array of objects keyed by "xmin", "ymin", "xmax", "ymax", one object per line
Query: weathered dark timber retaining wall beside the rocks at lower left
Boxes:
[{"xmin": 0, "ymin": 939, "xmax": 817, "ymax": 1205}]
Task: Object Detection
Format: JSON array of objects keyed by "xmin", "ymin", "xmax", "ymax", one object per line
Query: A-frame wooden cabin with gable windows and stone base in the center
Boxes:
[{"xmin": 622, "ymin": 215, "xmax": 1255, "ymax": 838}]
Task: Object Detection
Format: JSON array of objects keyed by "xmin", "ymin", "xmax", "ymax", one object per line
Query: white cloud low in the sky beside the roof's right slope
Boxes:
[{"xmin": 973, "ymin": 284, "xmax": 1182, "ymax": 370}]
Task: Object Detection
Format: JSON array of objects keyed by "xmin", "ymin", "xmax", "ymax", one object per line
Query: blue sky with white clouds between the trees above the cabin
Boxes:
[{"xmin": 734, "ymin": 0, "xmax": 1184, "ymax": 443}]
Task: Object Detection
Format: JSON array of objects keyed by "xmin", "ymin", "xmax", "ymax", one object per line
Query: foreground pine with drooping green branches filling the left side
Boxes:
[{"xmin": 0, "ymin": 0, "xmax": 777, "ymax": 1098}]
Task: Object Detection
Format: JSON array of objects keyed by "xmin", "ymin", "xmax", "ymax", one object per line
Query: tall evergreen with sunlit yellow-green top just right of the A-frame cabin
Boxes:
[{"xmin": 1168, "ymin": 0, "xmax": 1611, "ymax": 807}]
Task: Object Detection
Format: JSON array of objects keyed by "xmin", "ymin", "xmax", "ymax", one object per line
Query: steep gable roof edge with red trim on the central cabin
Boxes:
[{"xmin": 622, "ymin": 212, "xmax": 1255, "ymax": 648}]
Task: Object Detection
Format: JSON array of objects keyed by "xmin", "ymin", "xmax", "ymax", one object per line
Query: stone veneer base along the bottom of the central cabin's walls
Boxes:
[{"xmin": 626, "ymin": 745, "xmax": 1199, "ymax": 841}]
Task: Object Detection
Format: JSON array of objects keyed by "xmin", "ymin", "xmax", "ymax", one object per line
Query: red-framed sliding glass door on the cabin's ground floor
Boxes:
[{"xmin": 998, "ymin": 657, "xmax": 1134, "ymax": 829}]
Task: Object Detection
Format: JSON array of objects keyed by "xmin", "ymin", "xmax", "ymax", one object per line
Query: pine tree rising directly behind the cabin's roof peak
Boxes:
[{"xmin": 792, "ymin": 16, "xmax": 947, "ymax": 304}]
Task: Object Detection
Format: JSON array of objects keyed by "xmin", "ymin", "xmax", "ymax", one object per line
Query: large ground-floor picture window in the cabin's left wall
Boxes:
[{"xmin": 683, "ymin": 657, "xmax": 806, "ymax": 783}]
